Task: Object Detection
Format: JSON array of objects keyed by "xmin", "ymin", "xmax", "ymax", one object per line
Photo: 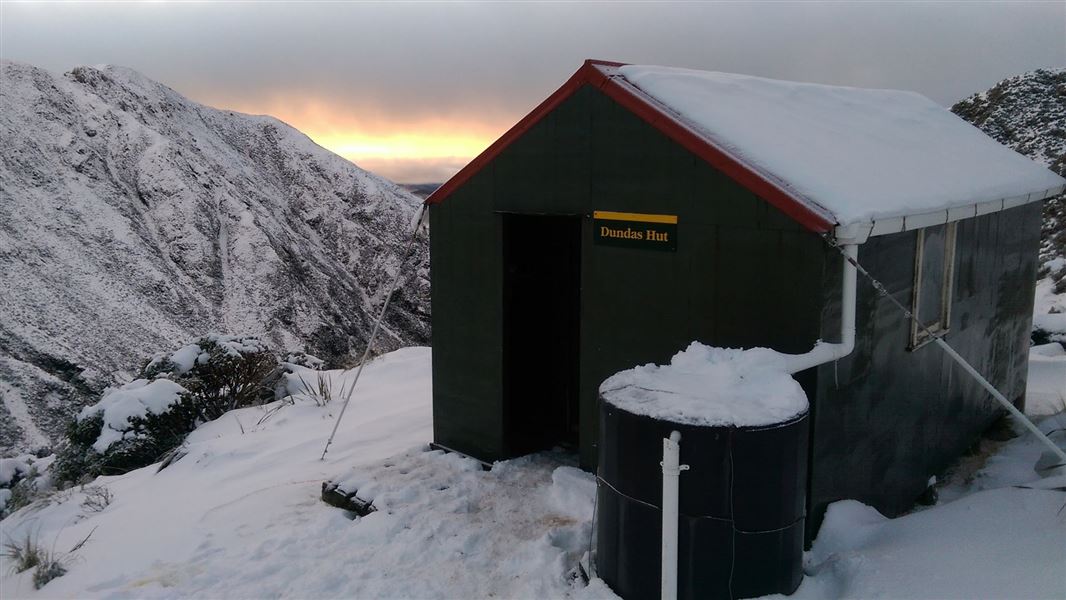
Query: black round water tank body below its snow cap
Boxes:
[{"xmin": 596, "ymin": 398, "xmax": 808, "ymax": 600}]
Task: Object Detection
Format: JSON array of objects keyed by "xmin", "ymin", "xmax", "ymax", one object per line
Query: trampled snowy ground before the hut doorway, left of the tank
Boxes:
[{"xmin": 0, "ymin": 347, "xmax": 611, "ymax": 599}]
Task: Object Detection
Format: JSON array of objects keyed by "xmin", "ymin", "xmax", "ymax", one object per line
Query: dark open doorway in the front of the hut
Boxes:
[{"xmin": 502, "ymin": 214, "xmax": 581, "ymax": 456}]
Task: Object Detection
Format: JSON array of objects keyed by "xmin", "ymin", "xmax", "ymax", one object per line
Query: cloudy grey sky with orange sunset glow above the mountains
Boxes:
[{"xmin": 0, "ymin": 0, "xmax": 1066, "ymax": 183}]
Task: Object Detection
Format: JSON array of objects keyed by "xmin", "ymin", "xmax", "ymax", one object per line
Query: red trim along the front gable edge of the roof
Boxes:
[{"xmin": 425, "ymin": 61, "xmax": 836, "ymax": 233}]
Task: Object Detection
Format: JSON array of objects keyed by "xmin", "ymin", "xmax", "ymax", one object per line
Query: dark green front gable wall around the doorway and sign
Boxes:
[{"xmin": 431, "ymin": 87, "xmax": 822, "ymax": 467}]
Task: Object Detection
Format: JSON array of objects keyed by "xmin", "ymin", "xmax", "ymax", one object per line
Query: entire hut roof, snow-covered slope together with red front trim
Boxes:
[{"xmin": 426, "ymin": 61, "xmax": 1066, "ymax": 238}]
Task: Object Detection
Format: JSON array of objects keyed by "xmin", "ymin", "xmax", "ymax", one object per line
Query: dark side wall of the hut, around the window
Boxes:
[{"xmin": 809, "ymin": 204, "xmax": 1040, "ymax": 528}]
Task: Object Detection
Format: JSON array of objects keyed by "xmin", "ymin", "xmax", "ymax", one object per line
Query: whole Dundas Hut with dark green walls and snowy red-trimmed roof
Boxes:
[{"xmin": 426, "ymin": 61, "xmax": 1064, "ymax": 528}]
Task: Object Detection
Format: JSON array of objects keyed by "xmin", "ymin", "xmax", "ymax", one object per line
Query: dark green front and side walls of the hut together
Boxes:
[{"xmin": 431, "ymin": 80, "xmax": 1039, "ymax": 534}]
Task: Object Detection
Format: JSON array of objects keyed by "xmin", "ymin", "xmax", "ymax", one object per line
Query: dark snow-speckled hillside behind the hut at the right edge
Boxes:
[{"xmin": 951, "ymin": 68, "xmax": 1066, "ymax": 293}]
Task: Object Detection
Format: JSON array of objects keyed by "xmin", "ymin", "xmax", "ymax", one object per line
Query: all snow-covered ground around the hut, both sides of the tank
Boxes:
[{"xmin": 0, "ymin": 348, "xmax": 1066, "ymax": 599}]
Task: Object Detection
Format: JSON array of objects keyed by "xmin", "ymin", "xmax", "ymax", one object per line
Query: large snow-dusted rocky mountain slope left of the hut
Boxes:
[{"xmin": 0, "ymin": 62, "xmax": 430, "ymax": 451}]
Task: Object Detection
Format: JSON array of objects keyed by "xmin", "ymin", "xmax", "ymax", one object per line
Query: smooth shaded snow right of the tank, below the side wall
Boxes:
[{"xmin": 794, "ymin": 413, "xmax": 1066, "ymax": 599}]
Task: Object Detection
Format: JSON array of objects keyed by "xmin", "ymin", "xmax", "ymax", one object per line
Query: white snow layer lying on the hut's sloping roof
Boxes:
[{"xmin": 617, "ymin": 65, "xmax": 1066, "ymax": 234}]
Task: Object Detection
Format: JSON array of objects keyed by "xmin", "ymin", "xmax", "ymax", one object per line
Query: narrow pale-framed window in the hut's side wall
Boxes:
[{"xmin": 910, "ymin": 223, "xmax": 955, "ymax": 350}]
